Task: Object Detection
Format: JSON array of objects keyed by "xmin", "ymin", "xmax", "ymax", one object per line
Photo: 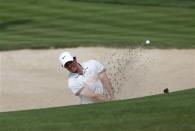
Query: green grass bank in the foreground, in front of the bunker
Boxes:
[{"xmin": 0, "ymin": 89, "xmax": 195, "ymax": 131}]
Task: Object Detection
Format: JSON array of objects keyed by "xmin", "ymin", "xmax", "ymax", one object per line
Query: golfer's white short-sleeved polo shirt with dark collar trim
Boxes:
[{"xmin": 68, "ymin": 60, "xmax": 107, "ymax": 104}]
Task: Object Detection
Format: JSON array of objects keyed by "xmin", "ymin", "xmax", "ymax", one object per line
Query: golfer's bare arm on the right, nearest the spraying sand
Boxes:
[{"xmin": 99, "ymin": 71, "xmax": 114, "ymax": 97}]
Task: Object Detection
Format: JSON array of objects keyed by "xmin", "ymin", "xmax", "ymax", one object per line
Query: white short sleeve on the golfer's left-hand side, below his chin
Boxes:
[{"xmin": 68, "ymin": 78, "xmax": 83, "ymax": 96}]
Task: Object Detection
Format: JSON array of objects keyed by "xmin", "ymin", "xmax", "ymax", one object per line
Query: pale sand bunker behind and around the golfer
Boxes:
[{"xmin": 0, "ymin": 48, "xmax": 195, "ymax": 112}]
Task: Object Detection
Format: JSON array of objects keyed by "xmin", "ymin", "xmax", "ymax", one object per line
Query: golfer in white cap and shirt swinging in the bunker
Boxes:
[{"xmin": 59, "ymin": 52, "xmax": 114, "ymax": 104}]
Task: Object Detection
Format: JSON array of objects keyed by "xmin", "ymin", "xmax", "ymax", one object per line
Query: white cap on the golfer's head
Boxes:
[{"xmin": 59, "ymin": 52, "xmax": 75, "ymax": 67}]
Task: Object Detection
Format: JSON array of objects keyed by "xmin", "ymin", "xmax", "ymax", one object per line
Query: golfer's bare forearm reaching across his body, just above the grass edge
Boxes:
[{"xmin": 79, "ymin": 87, "xmax": 110, "ymax": 102}]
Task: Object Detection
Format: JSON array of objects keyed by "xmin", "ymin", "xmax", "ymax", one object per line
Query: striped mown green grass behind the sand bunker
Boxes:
[{"xmin": 0, "ymin": 0, "xmax": 195, "ymax": 50}]
